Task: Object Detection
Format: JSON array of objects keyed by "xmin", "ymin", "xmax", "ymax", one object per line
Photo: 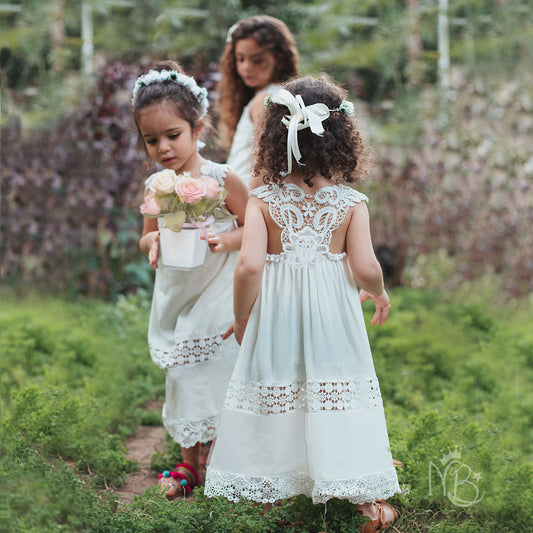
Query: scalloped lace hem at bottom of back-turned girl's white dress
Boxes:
[{"xmin": 204, "ymin": 467, "xmax": 400, "ymax": 504}]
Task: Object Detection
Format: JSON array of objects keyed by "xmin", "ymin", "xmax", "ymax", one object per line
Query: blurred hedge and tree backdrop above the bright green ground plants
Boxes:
[{"xmin": 0, "ymin": 0, "xmax": 533, "ymax": 298}]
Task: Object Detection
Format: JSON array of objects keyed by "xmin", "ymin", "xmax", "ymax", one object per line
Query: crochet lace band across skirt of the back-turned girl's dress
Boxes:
[{"xmin": 224, "ymin": 378, "xmax": 383, "ymax": 415}]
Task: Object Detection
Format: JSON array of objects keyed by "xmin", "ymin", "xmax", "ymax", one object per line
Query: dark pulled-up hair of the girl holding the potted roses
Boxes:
[{"xmin": 132, "ymin": 61, "xmax": 205, "ymax": 129}]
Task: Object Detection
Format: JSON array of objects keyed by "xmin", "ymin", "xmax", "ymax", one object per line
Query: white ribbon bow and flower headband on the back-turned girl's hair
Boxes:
[{"xmin": 265, "ymin": 89, "xmax": 355, "ymax": 176}]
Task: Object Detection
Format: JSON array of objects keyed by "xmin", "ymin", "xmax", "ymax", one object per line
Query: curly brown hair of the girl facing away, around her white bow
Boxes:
[{"xmin": 253, "ymin": 76, "xmax": 370, "ymax": 187}]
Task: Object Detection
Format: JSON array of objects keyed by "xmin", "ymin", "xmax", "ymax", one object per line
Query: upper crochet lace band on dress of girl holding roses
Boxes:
[{"xmin": 150, "ymin": 335, "xmax": 222, "ymax": 368}]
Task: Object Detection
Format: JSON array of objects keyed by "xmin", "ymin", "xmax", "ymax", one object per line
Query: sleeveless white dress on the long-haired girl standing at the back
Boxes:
[{"xmin": 227, "ymin": 84, "xmax": 281, "ymax": 187}]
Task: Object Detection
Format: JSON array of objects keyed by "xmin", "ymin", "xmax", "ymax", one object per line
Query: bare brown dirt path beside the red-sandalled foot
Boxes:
[{"xmin": 115, "ymin": 406, "xmax": 165, "ymax": 503}]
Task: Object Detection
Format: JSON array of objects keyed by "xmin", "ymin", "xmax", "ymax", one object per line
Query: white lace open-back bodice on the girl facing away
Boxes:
[{"xmin": 251, "ymin": 183, "xmax": 368, "ymax": 268}]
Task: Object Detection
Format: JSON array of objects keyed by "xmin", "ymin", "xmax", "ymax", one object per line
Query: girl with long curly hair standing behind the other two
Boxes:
[{"xmin": 217, "ymin": 15, "xmax": 298, "ymax": 186}]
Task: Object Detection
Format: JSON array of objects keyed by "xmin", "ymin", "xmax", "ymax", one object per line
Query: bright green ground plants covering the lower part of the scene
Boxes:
[{"xmin": 0, "ymin": 289, "xmax": 533, "ymax": 533}]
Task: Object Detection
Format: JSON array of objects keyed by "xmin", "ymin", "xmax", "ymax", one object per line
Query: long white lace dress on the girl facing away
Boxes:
[{"xmin": 205, "ymin": 184, "xmax": 400, "ymax": 503}]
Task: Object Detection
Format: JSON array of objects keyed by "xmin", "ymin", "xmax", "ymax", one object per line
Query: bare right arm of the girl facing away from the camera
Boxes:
[{"xmin": 346, "ymin": 202, "xmax": 390, "ymax": 326}]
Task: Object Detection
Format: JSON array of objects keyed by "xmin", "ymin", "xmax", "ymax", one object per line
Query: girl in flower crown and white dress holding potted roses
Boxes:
[{"xmin": 132, "ymin": 61, "xmax": 247, "ymax": 497}]
